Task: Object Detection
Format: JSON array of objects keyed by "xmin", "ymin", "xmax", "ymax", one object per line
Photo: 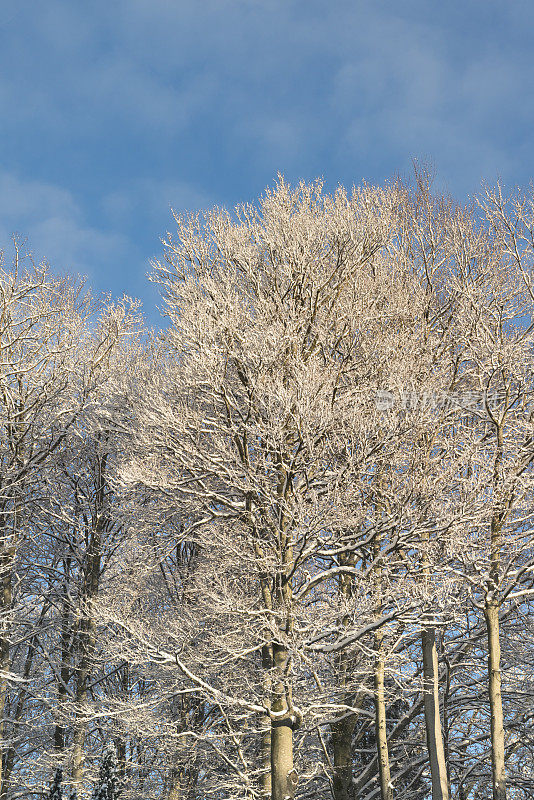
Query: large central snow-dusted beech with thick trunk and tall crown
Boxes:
[{"xmin": 105, "ymin": 177, "xmax": 428, "ymax": 799}]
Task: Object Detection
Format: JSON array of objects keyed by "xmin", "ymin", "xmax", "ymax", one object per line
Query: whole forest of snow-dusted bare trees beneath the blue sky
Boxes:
[{"xmin": 0, "ymin": 173, "xmax": 534, "ymax": 800}]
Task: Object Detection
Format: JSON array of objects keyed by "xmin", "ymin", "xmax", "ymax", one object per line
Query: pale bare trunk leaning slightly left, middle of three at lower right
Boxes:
[{"xmin": 422, "ymin": 627, "xmax": 449, "ymax": 800}]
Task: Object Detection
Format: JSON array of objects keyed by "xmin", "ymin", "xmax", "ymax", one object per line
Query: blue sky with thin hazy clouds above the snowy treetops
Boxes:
[{"xmin": 0, "ymin": 0, "xmax": 534, "ymax": 321}]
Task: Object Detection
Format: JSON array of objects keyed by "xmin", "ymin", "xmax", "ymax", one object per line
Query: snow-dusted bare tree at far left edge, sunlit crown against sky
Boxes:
[{"xmin": 0, "ymin": 243, "xmax": 144, "ymax": 798}]
